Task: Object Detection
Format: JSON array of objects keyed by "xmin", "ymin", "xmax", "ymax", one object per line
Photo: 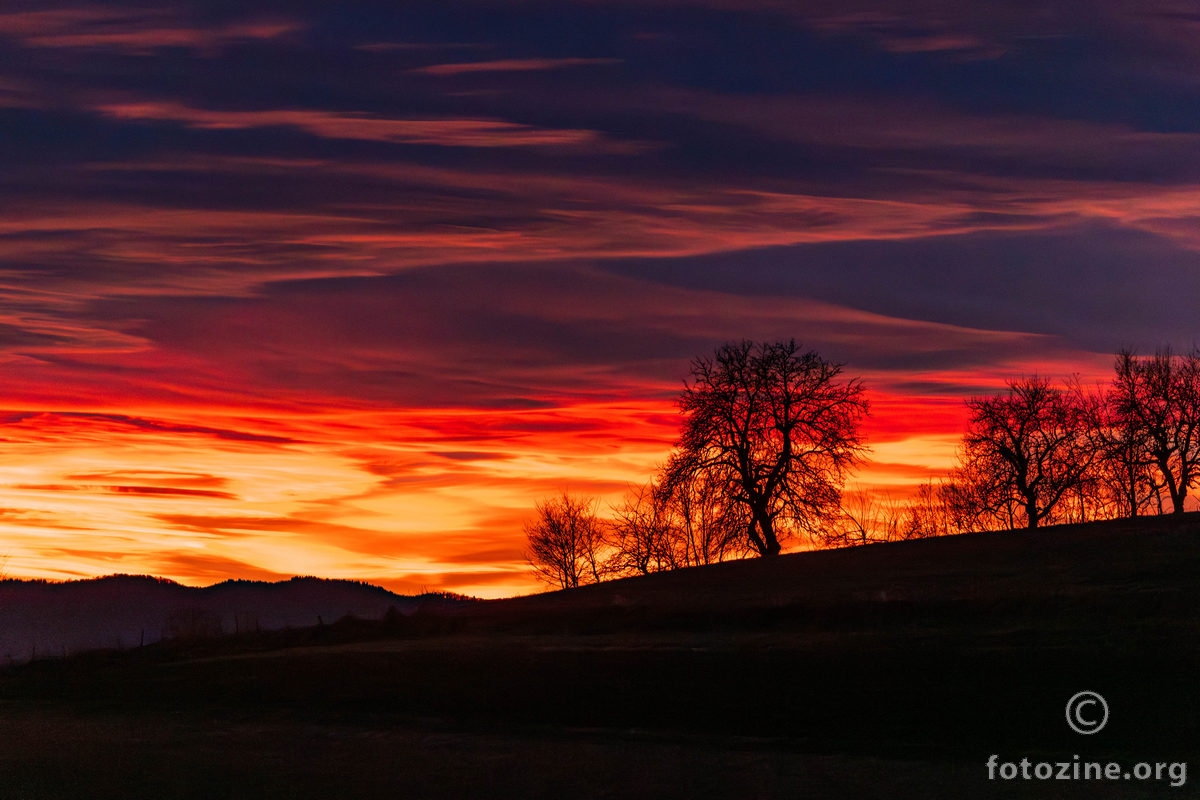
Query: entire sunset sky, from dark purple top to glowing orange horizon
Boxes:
[{"xmin": 0, "ymin": 0, "xmax": 1200, "ymax": 596}]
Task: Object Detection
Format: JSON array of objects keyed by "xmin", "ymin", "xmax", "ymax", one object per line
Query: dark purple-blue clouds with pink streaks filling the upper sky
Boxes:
[{"xmin": 0, "ymin": 0, "xmax": 1200, "ymax": 424}]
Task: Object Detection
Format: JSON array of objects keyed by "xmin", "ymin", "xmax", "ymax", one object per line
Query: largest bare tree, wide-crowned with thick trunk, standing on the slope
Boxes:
[{"xmin": 665, "ymin": 341, "xmax": 868, "ymax": 555}]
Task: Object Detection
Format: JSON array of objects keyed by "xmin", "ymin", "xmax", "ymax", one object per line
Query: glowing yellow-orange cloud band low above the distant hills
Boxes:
[{"xmin": 0, "ymin": 407, "xmax": 686, "ymax": 594}]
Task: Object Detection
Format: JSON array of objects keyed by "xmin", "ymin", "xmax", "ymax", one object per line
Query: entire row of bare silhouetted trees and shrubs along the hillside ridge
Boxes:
[{"xmin": 526, "ymin": 341, "xmax": 1200, "ymax": 589}]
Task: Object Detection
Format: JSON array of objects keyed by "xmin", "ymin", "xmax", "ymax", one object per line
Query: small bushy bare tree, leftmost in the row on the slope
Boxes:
[{"xmin": 526, "ymin": 492, "xmax": 605, "ymax": 589}]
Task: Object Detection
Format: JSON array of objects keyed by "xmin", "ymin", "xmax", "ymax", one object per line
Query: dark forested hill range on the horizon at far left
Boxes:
[{"xmin": 0, "ymin": 575, "xmax": 458, "ymax": 666}]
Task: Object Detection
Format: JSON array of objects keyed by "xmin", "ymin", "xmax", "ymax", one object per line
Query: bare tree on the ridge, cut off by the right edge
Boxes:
[{"xmin": 1109, "ymin": 349, "xmax": 1200, "ymax": 513}]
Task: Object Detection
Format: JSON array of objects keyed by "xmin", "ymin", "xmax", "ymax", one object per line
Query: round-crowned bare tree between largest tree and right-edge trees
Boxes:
[{"xmin": 952, "ymin": 377, "xmax": 1096, "ymax": 529}]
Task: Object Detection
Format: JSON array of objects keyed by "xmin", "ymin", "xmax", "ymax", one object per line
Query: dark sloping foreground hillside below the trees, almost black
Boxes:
[{"xmin": 0, "ymin": 515, "xmax": 1200, "ymax": 799}]
